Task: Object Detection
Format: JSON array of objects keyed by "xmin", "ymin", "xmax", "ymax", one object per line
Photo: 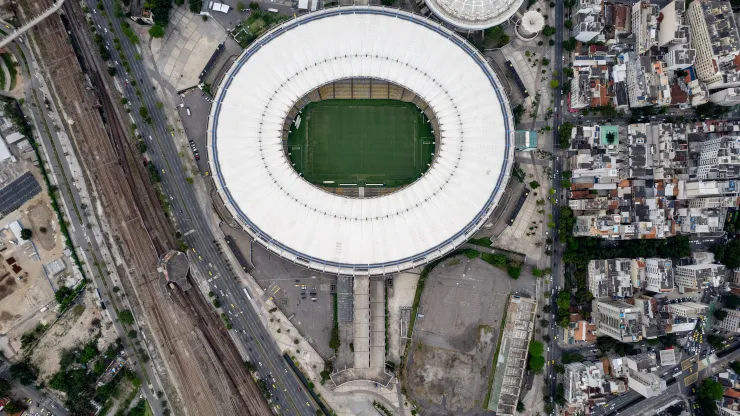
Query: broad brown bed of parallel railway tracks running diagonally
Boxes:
[{"xmin": 21, "ymin": 0, "xmax": 271, "ymax": 415}]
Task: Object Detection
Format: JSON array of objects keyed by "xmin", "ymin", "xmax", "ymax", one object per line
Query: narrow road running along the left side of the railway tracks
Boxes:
[{"xmin": 2, "ymin": 21, "xmax": 162, "ymax": 414}]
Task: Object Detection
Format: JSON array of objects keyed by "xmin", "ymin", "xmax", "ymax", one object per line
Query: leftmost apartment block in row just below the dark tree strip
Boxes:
[{"xmin": 588, "ymin": 259, "xmax": 633, "ymax": 298}]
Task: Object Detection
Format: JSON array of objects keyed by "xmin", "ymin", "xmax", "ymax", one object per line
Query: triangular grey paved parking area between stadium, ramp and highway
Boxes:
[{"xmin": 251, "ymin": 243, "xmax": 336, "ymax": 359}]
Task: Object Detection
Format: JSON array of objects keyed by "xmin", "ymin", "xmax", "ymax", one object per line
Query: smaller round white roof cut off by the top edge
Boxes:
[{"xmin": 425, "ymin": 0, "xmax": 524, "ymax": 30}]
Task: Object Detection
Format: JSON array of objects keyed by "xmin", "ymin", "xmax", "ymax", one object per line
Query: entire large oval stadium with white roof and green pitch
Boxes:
[{"xmin": 207, "ymin": 6, "xmax": 514, "ymax": 275}]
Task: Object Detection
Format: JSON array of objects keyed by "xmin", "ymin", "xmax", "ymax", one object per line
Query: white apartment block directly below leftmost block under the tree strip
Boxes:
[{"xmin": 592, "ymin": 299, "xmax": 642, "ymax": 342}]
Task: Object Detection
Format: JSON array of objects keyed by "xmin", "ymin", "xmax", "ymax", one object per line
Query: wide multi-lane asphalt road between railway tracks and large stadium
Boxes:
[{"xmin": 86, "ymin": 0, "xmax": 316, "ymax": 416}]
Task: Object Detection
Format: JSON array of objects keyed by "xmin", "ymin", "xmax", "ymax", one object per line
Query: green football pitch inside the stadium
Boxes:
[{"xmin": 288, "ymin": 100, "xmax": 434, "ymax": 187}]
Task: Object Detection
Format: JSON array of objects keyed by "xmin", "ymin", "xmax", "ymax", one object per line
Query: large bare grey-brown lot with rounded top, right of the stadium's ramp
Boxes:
[{"xmin": 406, "ymin": 256, "xmax": 533, "ymax": 415}]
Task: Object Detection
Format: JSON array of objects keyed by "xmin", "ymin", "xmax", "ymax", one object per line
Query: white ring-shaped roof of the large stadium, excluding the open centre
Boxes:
[{"xmin": 207, "ymin": 6, "xmax": 514, "ymax": 274}]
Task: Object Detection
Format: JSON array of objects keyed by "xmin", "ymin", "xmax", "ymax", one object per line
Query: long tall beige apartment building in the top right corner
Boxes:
[{"xmin": 686, "ymin": 0, "xmax": 740, "ymax": 89}]
